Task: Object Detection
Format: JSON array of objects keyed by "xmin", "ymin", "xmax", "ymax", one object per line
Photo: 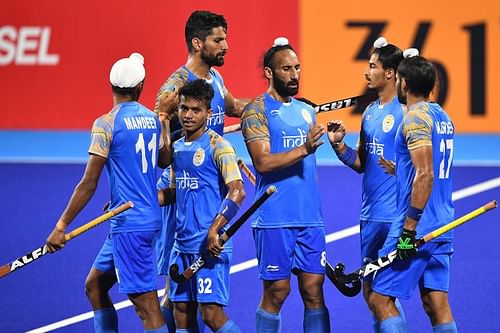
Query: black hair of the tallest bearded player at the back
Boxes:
[{"xmin": 184, "ymin": 10, "xmax": 227, "ymax": 53}]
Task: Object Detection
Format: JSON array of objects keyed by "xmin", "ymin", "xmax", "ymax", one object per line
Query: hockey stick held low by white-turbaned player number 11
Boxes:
[{"xmin": 0, "ymin": 201, "xmax": 134, "ymax": 277}]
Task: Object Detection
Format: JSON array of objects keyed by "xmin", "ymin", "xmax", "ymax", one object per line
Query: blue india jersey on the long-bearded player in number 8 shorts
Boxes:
[{"xmin": 241, "ymin": 94, "xmax": 323, "ymax": 228}]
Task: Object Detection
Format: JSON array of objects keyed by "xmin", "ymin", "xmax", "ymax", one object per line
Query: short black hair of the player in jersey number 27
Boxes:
[{"xmin": 398, "ymin": 56, "xmax": 436, "ymax": 98}]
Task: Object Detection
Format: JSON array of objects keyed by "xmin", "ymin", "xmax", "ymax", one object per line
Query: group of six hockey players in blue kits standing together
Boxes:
[{"xmin": 47, "ymin": 11, "xmax": 457, "ymax": 333}]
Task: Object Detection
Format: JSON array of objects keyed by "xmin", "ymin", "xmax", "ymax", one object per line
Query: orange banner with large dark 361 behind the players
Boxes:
[{"xmin": 299, "ymin": 0, "xmax": 500, "ymax": 133}]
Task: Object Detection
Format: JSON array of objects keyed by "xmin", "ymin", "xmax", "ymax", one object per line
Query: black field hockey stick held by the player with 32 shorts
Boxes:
[{"xmin": 169, "ymin": 185, "xmax": 276, "ymax": 283}]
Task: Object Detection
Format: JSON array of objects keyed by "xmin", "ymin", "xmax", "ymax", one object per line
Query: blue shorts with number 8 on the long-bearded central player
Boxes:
[{"xmin": 253, "ymin": 227, "xmax": 326, "ymax": 281}]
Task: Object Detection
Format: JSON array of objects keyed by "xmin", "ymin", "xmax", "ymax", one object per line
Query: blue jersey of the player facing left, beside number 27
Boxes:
[{"xmin": 358, "ymin": 97, "xmax": 403, "ymax": 223}]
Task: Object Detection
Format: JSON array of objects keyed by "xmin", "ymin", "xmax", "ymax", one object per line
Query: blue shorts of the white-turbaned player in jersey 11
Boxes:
[{"xmin": 92, "ymin": 231, "xmax": 158, "ymax": 294}]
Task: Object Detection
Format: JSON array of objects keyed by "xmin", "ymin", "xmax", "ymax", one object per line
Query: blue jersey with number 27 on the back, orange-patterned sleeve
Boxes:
[{"xmin": 389, "ymin": 102, "xmax": 455, "ymax": 241}]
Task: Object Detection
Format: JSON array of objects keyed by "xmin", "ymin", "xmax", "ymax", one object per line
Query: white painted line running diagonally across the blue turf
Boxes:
[{"xmin": 26, "ymin": 177, "xmax": 500, "ymax": 333}]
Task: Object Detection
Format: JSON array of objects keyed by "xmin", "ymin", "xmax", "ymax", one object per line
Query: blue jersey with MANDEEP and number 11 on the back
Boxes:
[{"xmin": 89, "ymin": 102, "xmax": 163, "ymax": 233}]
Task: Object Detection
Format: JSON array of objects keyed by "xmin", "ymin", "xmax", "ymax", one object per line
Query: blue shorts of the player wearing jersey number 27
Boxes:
[{"xmin": 372, "ymin": 237, "xmax": 453, "ymax": 299}]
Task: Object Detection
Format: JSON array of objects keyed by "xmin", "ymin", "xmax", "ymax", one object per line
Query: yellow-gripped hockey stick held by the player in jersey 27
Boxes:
[{"xmin": 333, "ymin": 200, "xmax": 497, "ymax": 284}]
